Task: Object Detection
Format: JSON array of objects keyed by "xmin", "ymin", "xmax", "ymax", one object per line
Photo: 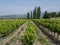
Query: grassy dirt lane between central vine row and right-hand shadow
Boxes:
[{"xmin": 32, "ymin": 20, "xmax": 55, "ymax": 45}]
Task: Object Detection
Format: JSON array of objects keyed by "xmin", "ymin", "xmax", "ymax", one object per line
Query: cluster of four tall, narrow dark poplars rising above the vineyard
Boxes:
[{"xmin": 27, "ymin": 7, "xmax": 41, "ymax": 19}]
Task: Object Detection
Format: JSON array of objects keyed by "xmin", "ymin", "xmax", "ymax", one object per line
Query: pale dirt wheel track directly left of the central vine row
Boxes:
[{"xmin": 10, "ymin": 23, "xmax": 28, "ymax": 45}]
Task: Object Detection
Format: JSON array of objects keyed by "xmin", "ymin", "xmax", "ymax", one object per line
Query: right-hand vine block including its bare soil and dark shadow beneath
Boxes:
[{"xmin": 34, "ymin": 19, "xmax": 60, "ymax": 45}]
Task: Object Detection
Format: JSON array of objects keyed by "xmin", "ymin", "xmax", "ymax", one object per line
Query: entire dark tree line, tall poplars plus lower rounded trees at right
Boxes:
[{"xmin": 27, "ymin": 7, "xmax": 60, "ymax": 19}]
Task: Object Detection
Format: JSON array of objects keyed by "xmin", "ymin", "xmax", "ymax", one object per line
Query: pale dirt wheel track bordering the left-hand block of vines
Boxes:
[{"xmin": 0, "ymin": 23, "xmax": 26, "ymax": 45}]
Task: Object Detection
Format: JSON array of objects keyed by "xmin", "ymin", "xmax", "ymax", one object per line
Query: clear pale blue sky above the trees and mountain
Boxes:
[{"xmin": 0, "ymin": 0, "xmax": 60, "ymax": 15}]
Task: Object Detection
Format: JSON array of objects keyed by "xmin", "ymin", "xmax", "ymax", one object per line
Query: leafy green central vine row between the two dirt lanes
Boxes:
[{"xmin": 23, "ymin": 22, "xmax": 36, "ymax": 45}]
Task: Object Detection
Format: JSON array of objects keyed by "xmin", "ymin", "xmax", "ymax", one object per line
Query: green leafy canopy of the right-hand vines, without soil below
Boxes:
[{"xmin": 36, "ymin": 19, "xmax": 60, "ymax": 36}]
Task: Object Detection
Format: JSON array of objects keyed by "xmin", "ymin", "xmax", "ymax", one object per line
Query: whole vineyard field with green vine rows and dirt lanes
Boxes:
[{"xmin": 0, "ymin": 19, "xmax": 60, "ymax": 45}]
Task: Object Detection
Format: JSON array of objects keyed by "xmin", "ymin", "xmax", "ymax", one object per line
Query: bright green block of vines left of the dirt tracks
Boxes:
[{"xmin": 0, "ymin": 20, "xmax": 25, "ymax": 38}]
